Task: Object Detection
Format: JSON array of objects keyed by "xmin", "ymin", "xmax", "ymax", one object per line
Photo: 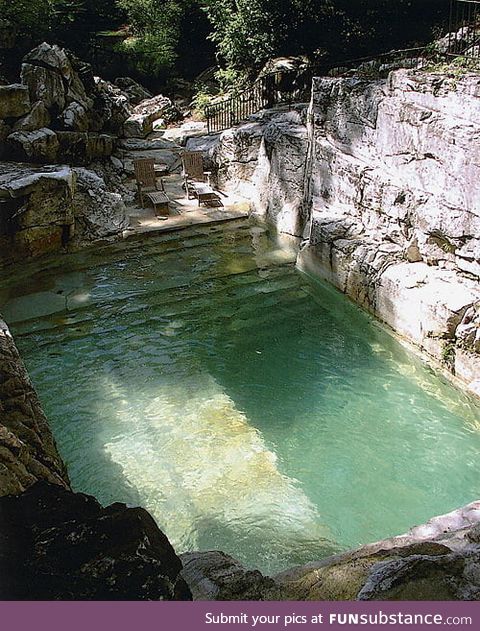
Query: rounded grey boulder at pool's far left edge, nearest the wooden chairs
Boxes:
[{"xmin": 73, "ymin": 168, "xmax": 128, "ymax": 244}]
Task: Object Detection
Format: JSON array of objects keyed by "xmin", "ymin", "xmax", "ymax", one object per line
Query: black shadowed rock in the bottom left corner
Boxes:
[{"xmin": 0, "ymin": 482, "xmax": 191, "ymax": 600}]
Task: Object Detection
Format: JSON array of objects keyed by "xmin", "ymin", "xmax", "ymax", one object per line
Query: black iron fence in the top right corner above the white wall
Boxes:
[{"xmin": 448, "ymin": 0, "xmax": 480, "ymax": 59}]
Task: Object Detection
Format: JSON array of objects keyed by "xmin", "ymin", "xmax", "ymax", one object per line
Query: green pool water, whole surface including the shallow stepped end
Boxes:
[{"xmin": 0, "ymin": 222, "xmax": 480, "ymax": 573}]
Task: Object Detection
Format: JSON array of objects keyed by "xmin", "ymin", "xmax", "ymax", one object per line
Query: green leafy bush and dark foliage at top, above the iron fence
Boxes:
[{"xmin": 201, "ymin": 0, "xmax": 449, "ymax": 75}]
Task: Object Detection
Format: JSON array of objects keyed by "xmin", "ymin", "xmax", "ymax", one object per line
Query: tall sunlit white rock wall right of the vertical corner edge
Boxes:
[{"xmin": 300, "ymin": 70, "xmax": 480, "ymax": 393}]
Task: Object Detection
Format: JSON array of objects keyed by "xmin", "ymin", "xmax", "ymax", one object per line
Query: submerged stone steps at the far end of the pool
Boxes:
[{"xmin": 4, "ymin": 221, "xmax": 296, "ymax": 335}]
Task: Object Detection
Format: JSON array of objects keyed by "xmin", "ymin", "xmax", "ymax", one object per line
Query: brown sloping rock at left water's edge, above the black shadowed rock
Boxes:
[{"xmin": 0, "ymin": 319, "xmax": 69, "ymax": 496}]
